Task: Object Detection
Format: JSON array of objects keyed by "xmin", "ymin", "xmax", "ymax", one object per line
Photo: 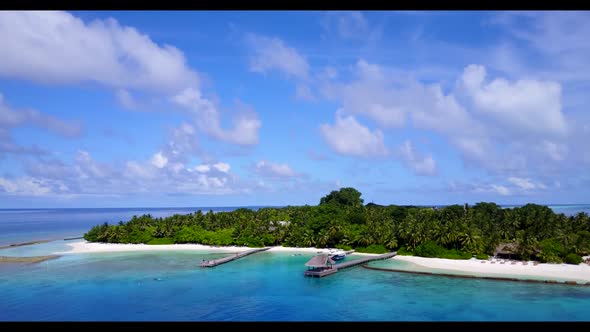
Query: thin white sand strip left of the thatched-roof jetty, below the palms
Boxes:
[{"xmin": 53, "ymin": 241, "xmax": 378, "ymax": 256}]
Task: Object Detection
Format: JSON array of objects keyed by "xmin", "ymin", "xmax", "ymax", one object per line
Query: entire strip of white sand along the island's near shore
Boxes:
[{"xmin": 25, "ymin": 241, "xmax": 590, "ymax": 286}]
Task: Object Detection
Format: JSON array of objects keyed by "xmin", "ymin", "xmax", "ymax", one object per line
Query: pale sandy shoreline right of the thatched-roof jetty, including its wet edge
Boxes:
[{"xmin": 363, "ymin": 256, "xmax": 590, "ymax": 285}]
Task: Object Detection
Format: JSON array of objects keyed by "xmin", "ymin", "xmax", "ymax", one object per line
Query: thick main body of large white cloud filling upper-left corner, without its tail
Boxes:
[{"xmin": 0, "ymin": 11, "xmax": 198, "ymax": 92}]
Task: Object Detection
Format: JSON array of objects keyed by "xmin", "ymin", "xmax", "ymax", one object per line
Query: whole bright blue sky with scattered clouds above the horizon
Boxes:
[{"xmin": 0, "ymin": 11, "xmax": 590, "ymax": 208}]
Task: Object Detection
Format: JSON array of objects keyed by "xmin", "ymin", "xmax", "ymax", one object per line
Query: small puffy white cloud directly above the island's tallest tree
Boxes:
[{"xmin": 320, "ymin": 111, "xmax": 389, "ymax": 157}]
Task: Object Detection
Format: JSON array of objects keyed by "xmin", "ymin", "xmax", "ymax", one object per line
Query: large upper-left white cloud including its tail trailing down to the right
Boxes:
[{"xmin": 0, "ymin": 11, "xmax": 261, "ymax": 145}]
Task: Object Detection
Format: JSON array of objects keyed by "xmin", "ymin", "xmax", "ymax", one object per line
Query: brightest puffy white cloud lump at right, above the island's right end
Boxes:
[{"xmin": 461, "ymin": 65, "xmax": 567, "ymax": 135}]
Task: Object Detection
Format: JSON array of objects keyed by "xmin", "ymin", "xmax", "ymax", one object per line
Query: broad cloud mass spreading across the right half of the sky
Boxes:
[{"xmin": 320, "ymin": 59, "xmax": 584, "ymax": 180}]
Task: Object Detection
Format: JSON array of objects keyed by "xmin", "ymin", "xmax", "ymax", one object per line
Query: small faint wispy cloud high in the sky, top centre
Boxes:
[{"xmin": 247, "ymin": 34, "xmax": 309, "ymax": 79}]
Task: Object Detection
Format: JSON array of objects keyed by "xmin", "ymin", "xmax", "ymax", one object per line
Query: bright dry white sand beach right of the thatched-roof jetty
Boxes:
[{"xmin": 391, "ymin": 256, "xmax": 590, "ymax": 282}]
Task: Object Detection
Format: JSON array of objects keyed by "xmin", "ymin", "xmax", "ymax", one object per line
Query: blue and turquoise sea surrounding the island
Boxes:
[{"xmin": 0, "ymin": 205, "xmax": 590, "ymax": 321}]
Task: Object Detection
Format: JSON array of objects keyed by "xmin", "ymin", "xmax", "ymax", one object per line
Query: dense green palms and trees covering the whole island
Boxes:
[{"xmin": 84, "ymin": 188, "xmax": 590, "ymax": 263}]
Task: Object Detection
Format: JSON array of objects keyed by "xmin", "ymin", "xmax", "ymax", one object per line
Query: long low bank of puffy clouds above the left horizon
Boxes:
[{"xmin": 0, "ymin": 151, "xmax": 240, "ymax": 197}]
